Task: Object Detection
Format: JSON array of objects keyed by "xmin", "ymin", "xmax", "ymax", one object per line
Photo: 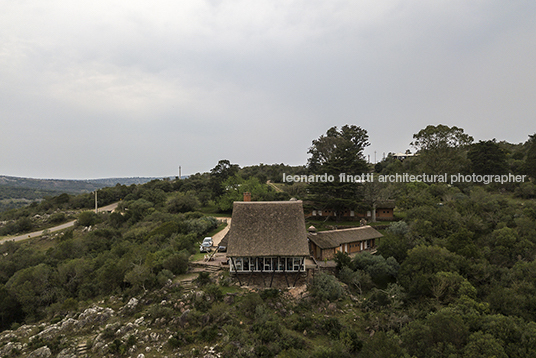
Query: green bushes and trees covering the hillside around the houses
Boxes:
[{"xmin": 0, "ymin": 126, "xmax": 536, "ymax": 358}]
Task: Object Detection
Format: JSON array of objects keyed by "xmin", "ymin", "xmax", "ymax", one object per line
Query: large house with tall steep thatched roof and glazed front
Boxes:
[{"xmin": 227, "ymin": 201, "xmax": 309, "ymax": 272}]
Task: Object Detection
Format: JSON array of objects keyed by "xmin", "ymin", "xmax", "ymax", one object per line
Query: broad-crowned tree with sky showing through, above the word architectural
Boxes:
[{"xmin": 410, "ymin": 124, "xmax": 473, "ymax": 174}]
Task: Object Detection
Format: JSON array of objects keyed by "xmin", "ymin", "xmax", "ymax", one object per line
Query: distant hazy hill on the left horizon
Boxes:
[{"xmin": 0, "ymin": 175, "xmax": 172, "ymax": 211}]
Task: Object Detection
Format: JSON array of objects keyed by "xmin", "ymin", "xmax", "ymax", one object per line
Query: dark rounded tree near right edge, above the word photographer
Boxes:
[{"xmin": 467, "ymin": 139, "xmax": 508, "ymax": 175}]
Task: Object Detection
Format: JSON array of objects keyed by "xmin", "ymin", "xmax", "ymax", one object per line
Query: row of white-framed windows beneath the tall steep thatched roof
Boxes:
[{"xmin": 229, "ymin": 257, "xmax": 305, "ymax": 272}]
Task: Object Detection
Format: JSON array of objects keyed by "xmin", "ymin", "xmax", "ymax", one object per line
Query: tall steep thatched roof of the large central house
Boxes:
[{"xmin": 227, "ymin": 201, "xmax": 309, "ymax": 257}]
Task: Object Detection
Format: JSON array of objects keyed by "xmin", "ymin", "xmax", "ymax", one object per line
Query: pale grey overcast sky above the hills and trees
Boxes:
[{"xmin": 0, "ymin": 0, "xmax": 536, "ymax": 179}]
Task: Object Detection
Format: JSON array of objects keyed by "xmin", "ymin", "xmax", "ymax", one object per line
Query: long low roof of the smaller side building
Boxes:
[{"xmin": 308, "ymin": 226, "xmax": 383, "ymax": 249}]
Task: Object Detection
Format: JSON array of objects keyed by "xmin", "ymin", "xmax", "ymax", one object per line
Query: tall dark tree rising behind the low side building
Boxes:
[{"xmin": 307, "ymin": 125, "xmax": 370, "ymax": 217}]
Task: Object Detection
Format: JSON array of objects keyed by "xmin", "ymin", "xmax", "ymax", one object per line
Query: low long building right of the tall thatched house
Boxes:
[{"xmin": 307, "ymin": 226, "xmax": 383, "ymax": 260}]
